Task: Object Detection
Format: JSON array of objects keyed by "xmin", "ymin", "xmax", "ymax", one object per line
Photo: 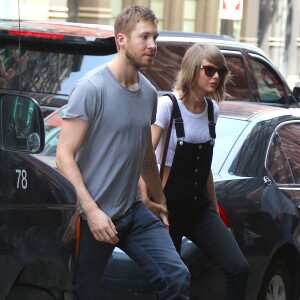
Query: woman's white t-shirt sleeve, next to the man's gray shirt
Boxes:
[{"xmin": 154, "ymin": 96, "xmax": 173, "ymax": 129}]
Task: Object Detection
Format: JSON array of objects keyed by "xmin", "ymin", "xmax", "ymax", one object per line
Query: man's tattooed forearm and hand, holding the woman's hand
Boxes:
[{"xmin": 139, "ymin": 133, "xmax": 169, "ymax": 227}]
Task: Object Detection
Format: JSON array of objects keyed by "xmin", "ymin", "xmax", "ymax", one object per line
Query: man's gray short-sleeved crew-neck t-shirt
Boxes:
[{"xmin": 64, "ymin": 65, "xmax": 157, "ymax": 219}]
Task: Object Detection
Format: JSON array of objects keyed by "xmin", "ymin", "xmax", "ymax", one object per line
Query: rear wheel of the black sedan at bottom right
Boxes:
[{"xmin": 257, "ymin": 259, "xmax": 291, "ymax": 300}]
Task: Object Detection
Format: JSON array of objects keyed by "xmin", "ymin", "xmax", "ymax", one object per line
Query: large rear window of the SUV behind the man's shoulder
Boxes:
[{"xmin": 0, "ymin": 44, "xmax": 115, "ymax": 95}]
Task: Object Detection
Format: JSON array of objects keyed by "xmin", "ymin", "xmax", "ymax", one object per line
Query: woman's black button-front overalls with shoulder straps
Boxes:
[{"xmin": 164, "ymin": 94, "xmax": 249, "ymax": 300}]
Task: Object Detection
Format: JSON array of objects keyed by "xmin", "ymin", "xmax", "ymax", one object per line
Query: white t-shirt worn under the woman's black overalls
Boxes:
[{"xmin": 154, "ymin": 93, "xmax": 219, "ymax": 167}]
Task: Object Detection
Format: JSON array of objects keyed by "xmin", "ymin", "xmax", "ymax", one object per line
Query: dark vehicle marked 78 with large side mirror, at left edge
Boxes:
[{"xmin": 0, "ymin": 94, "xmax": 78, "ymax": 300}]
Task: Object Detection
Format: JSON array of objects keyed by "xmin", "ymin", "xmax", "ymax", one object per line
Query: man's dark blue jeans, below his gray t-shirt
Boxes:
[{"xmin": 73, "ymin": 202, "xmax": 190, "ymax": 300}]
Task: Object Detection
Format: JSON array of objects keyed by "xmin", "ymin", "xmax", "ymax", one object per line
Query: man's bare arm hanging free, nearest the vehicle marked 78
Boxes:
[{"xmin": 56, "ymin": 118, "xmax": 119, "ymax": 244}]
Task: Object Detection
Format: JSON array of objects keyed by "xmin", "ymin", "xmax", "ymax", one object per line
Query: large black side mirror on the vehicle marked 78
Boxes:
[{"xmin": 0, "ymin": 94, "xmax": 45, "ymax": 154}]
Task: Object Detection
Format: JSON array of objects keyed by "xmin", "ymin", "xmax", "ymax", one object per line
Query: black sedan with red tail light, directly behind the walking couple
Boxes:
[{"xmin": 38, "ymin": 101, "xmax": 300, "ymax": 300}]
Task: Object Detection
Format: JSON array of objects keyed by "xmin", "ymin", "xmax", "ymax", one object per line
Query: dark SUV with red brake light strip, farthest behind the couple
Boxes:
[{"xmin": 0, "ymin": 20, "xmax": 300, "ymax": 116}]
